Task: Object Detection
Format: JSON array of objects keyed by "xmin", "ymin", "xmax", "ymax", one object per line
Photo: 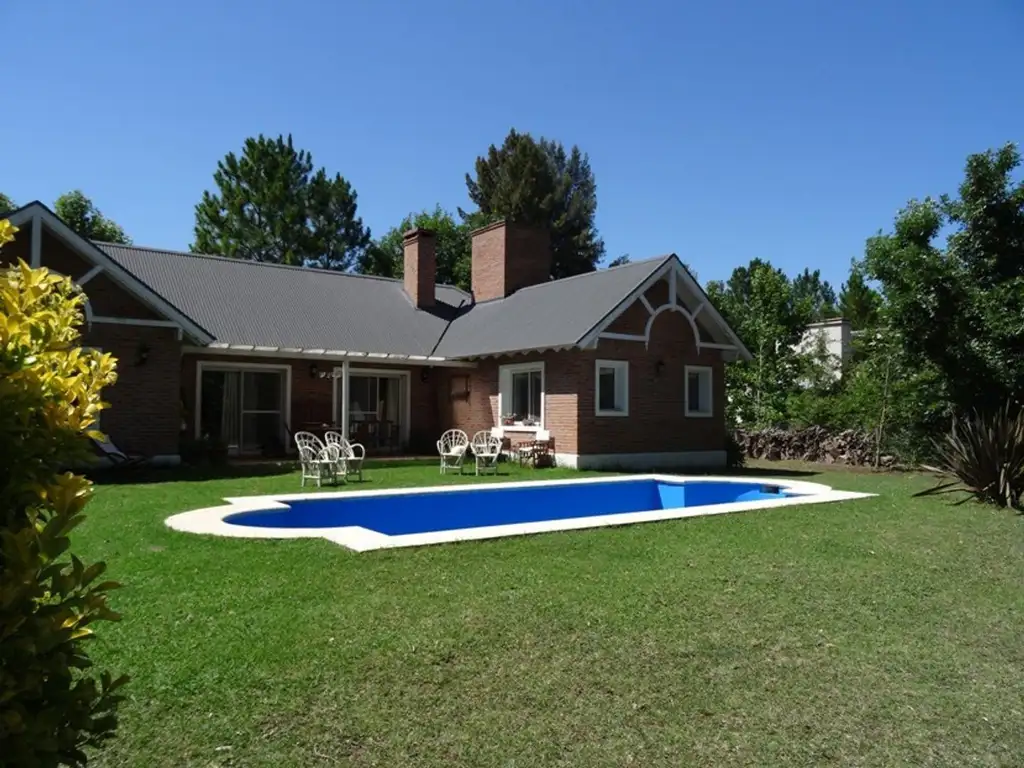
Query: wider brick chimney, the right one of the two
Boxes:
[{"xmin": 472, "ymin": 221, "xmax": 551, "ymax": 301}]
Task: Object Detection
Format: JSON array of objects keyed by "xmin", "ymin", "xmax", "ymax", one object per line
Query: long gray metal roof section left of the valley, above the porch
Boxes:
[{"xmin": 96, "ymin": 243, "xmax": 470, "ymax": 355}]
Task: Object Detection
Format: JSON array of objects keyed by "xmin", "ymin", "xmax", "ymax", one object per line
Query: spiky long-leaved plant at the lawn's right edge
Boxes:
[{"xmin": 921, "ymin": 402, "xmax": 1024, "ymax": 512}]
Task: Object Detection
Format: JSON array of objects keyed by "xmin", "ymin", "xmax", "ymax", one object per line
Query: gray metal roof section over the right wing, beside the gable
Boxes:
[{"xmin": 436, "ymin": 256, "xmax": 674, "ymax": 357}]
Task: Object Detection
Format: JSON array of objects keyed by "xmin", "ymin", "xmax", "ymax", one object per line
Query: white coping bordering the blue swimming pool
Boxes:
[{"xmin": 166, "ymin": 474, "xmax": 874, "ymax": 552}]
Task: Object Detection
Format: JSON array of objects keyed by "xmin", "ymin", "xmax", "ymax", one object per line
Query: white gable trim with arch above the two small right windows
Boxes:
[{"xmin": 579, "ymin": 254, "xmax": 753, "ymax": 360}]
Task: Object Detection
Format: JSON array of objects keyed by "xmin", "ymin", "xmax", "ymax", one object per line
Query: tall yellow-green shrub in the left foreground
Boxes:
[{"xmin": 0, "ymin": 221, "xmax": 126, "ymax": 767}]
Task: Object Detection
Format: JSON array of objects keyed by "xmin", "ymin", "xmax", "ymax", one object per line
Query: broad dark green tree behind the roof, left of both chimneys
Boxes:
[{"xmin": 191, "ymin": 134, "xmax": 370, "ymax": 269}]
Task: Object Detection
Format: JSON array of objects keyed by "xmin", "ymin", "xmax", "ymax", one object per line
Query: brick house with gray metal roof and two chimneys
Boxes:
[{"xmin": 0, "ymin": 202, "xmax": 750, "ymax": 468}]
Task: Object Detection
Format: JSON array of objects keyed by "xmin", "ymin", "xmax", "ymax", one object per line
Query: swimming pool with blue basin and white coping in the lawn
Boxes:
[{"xmin": 167, "ymin": 475, "xmax": 869, "ymax": 551}]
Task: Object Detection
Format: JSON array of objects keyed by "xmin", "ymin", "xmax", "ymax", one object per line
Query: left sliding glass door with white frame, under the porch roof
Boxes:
[{"xmin": 200, "ymin": 368, "xmax": 286, "ymax": 456}]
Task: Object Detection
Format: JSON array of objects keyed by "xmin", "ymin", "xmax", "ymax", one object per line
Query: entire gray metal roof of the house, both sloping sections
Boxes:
[{"xmin": 96, "ymin": 243, "xmax": 673, "ymax": 358}]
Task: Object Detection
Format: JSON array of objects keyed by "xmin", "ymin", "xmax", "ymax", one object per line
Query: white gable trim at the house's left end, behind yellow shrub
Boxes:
[{"xmin": 9, "ymin": 201, "xmax": 214, "ymax": 344}]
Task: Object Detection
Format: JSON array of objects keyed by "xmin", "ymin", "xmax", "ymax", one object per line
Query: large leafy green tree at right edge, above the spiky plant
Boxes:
[{"xmin": 865, "ymin": 144, "xmax": 1024, "ymax": 421}]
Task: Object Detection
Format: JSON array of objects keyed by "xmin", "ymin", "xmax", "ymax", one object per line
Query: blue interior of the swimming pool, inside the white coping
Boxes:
[{"xmin": 224, "ymin": 478, "xmax": 793, "ymax": 536}]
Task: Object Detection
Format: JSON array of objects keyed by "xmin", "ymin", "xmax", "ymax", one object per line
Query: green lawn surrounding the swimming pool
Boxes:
[{"xmin": 76, "ymin": 465, "xmax": 1024, "ymax": 768}]
